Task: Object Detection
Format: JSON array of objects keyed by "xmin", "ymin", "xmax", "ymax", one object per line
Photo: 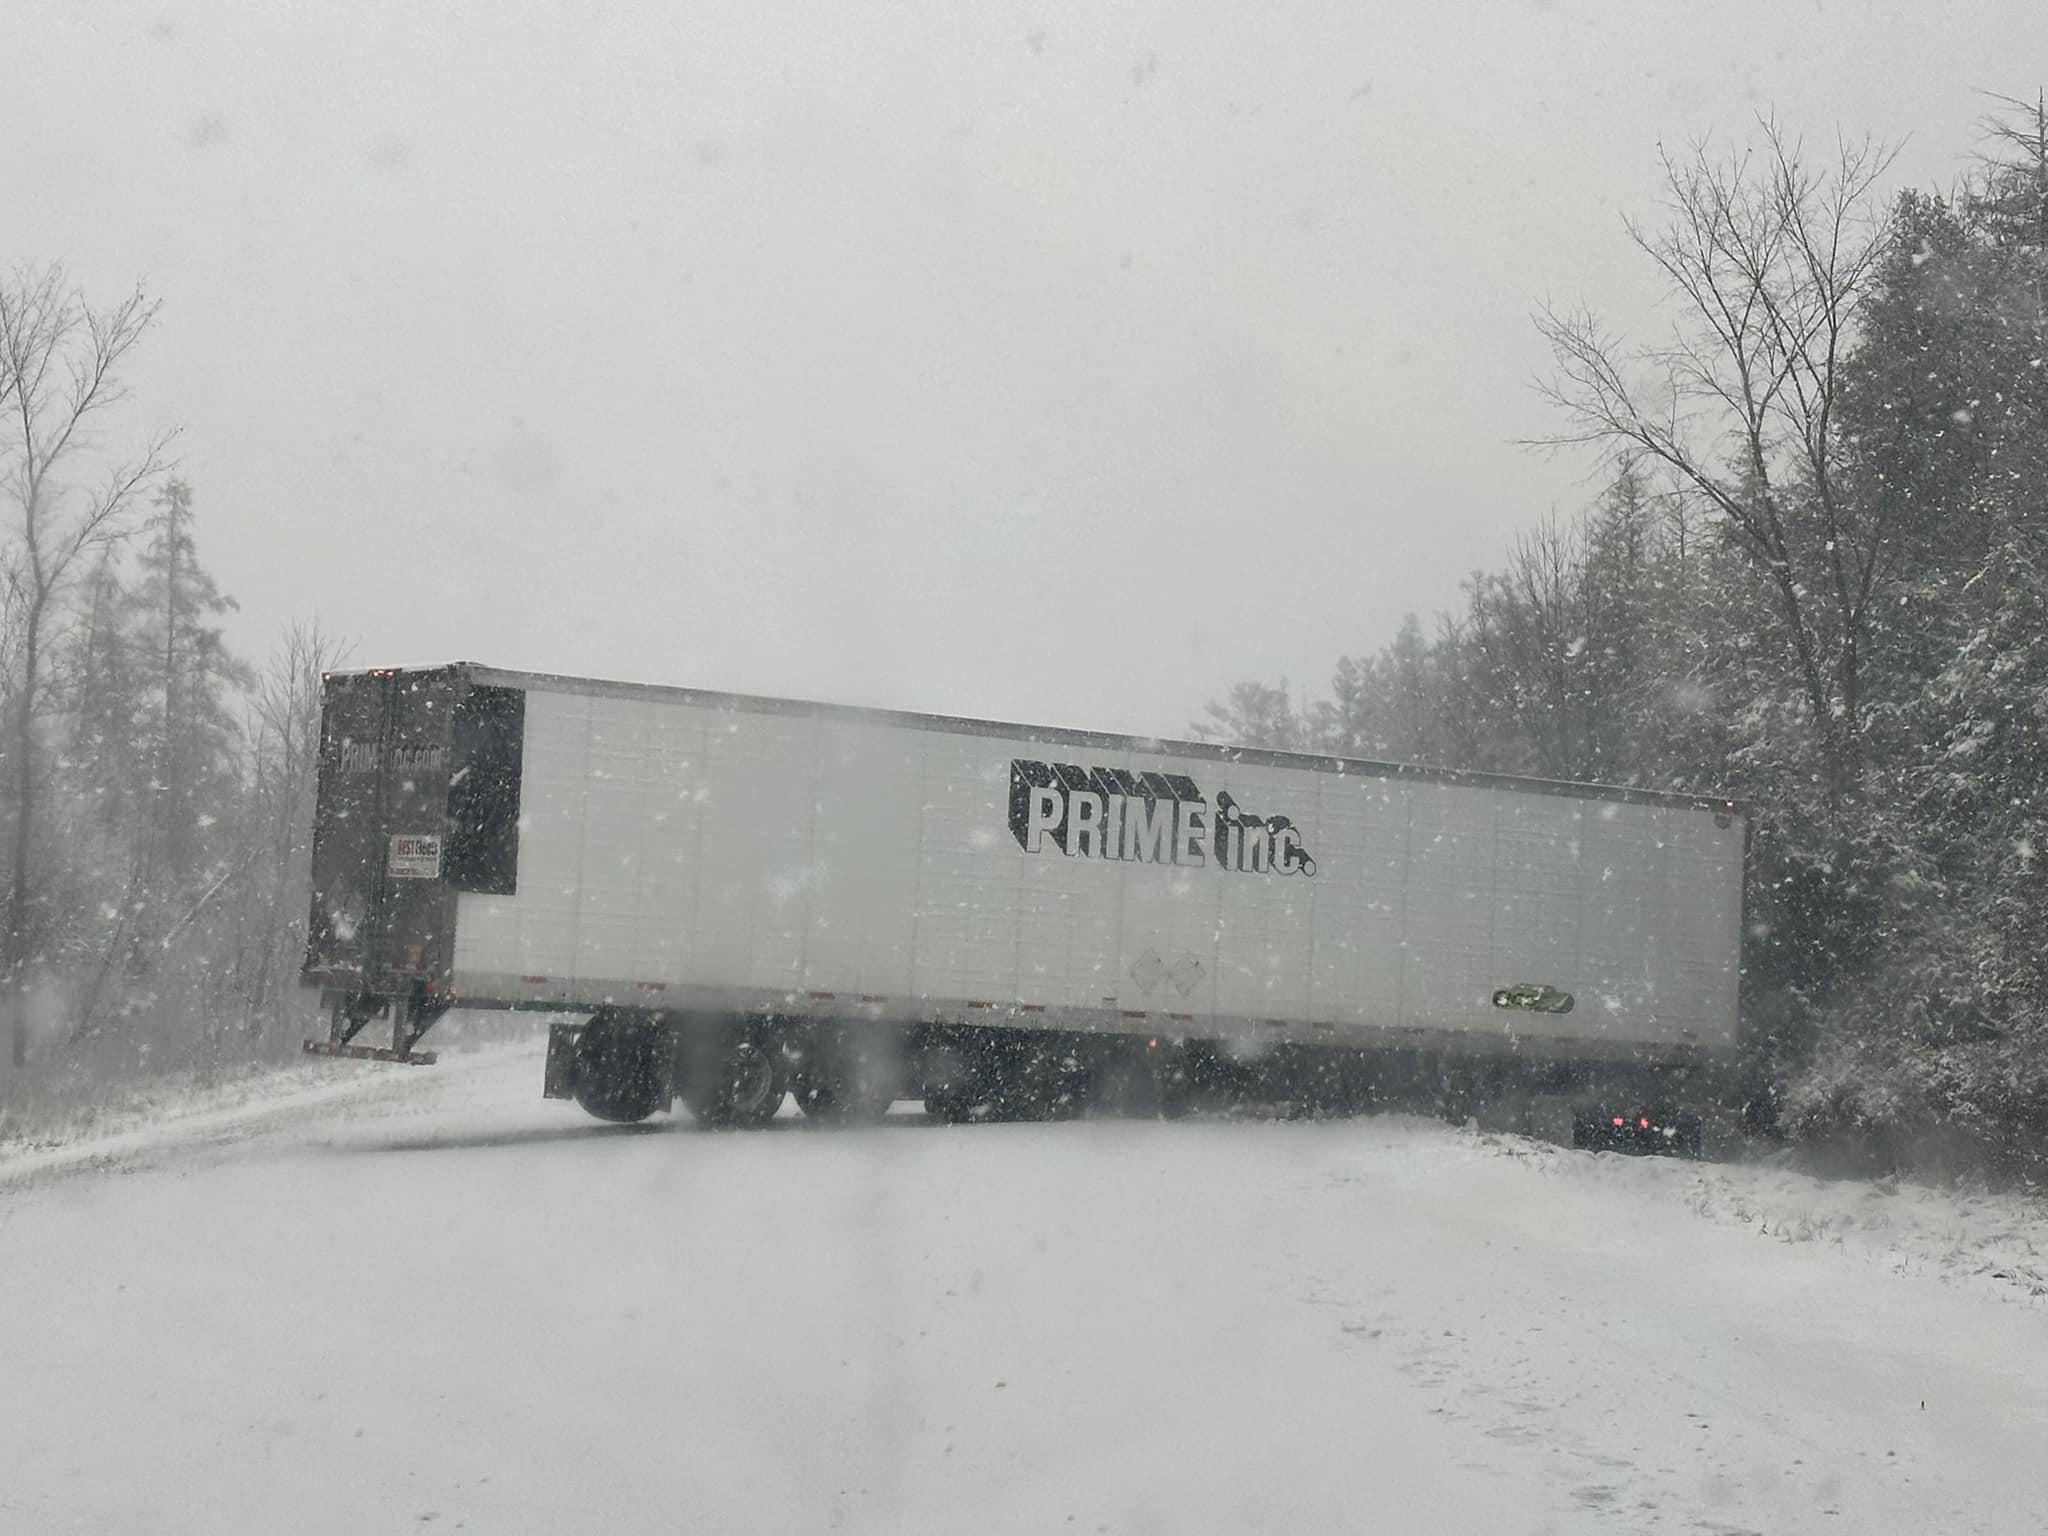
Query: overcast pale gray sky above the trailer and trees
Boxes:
[{"xmin": 0, "ymin": 0, "xmax": 2048, "ymax": 733}]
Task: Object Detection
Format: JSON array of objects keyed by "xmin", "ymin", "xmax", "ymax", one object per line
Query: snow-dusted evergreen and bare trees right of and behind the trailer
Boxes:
[{"xmin": 1194, "ymin": 100, "xmax": 2048, "ymax": 1159}]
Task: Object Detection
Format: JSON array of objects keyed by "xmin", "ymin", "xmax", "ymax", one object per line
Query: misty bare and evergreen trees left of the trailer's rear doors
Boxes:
[{"xmin": 0, "ymin": 266, "xmax": 338, "ymax": 1110}]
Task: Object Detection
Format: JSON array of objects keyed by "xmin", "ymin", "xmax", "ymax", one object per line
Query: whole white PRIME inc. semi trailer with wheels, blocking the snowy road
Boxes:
[{"xmin": 305, "ymin": 664, "xmax": 1749, "ymax": 1151}]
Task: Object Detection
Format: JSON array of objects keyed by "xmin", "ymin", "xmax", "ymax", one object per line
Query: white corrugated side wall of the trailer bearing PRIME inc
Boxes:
[{"xmin": 455, "ymin": 674, "xmax": 1745, "ymax": 1053}]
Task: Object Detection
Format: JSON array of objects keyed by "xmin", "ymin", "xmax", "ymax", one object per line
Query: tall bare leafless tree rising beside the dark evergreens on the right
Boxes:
[{"xmin": 1538, "ymin": 121, "xmax": 1894, "ymax": 799}]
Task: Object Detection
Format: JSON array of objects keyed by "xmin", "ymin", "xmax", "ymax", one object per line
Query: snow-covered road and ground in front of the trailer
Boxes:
[{"xmin": 0, "ymin": 1042, "xmax": 2048, "ymax": 1536}]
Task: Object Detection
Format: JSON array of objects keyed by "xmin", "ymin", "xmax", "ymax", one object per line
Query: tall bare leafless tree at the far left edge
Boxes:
[{"xmin": 0, "ymin": 266, "xmax": 170, "ymax": 1067}]
